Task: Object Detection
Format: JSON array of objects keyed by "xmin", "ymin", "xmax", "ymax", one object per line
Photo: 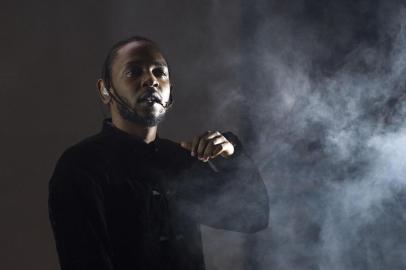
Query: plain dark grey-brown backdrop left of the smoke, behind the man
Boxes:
[{"xmin": 0, "ymin": 0, "xmax": 244, "ymax": 270}]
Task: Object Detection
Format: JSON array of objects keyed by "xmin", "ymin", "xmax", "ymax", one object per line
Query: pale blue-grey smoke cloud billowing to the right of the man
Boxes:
[{"xmin": 203, "ymin": 1, "xmax": 406, "ymax": 270}]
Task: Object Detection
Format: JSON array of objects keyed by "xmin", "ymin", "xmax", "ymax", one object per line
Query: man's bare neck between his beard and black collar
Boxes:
[{"xmin": 111, "ymin": 114, "xmax": 157, "ymax": 143}]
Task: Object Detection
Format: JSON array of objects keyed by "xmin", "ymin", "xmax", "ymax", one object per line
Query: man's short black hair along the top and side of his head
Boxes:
[{"xmin": 101, "ymin": 36, "xmax": 158, "ymax": 89}]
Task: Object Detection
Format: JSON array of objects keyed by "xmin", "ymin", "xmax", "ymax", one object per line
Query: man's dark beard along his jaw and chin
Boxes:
[{"xmin": 117, "ymin": 97, "xmax": 165, "ymax": 127}]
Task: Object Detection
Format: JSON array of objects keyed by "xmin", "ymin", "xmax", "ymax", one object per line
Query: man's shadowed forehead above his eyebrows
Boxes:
[{"xmin": 113, "ymin": 41, "xmax": 167, "ymax": 69}]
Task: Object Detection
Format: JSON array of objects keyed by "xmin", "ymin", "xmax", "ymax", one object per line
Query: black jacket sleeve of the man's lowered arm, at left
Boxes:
[{"xmin": 48, "ymin": 152, "xmax": 114, "ymax": 270}]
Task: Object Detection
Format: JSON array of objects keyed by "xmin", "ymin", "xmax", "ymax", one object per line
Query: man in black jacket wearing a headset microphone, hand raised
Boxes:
[{"xmin": 49, "ymin": 37, "xmax": 268, "ymax": 270}]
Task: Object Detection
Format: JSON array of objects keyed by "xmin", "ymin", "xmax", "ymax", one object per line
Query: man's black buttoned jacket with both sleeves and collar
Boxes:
[{"xmin": 49, "ymin": 120, "xmax": 268, "ymax": 270}]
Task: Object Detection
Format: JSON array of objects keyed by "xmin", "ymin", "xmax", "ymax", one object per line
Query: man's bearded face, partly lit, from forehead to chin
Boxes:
[{"xmin": 111, "ymin": 41, "xmax": 170, "ymax": 126}]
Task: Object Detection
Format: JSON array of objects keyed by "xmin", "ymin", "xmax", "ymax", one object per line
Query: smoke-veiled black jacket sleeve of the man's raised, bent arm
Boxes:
[{"xmin": 172, "ymin": 133, "xmax": 269, "ymax": 233}]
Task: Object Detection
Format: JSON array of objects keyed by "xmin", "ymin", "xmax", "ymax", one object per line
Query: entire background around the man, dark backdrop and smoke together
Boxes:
[{"xmin": 0, "ymin": 0, "xmax": 406, "ymax": 270}]
